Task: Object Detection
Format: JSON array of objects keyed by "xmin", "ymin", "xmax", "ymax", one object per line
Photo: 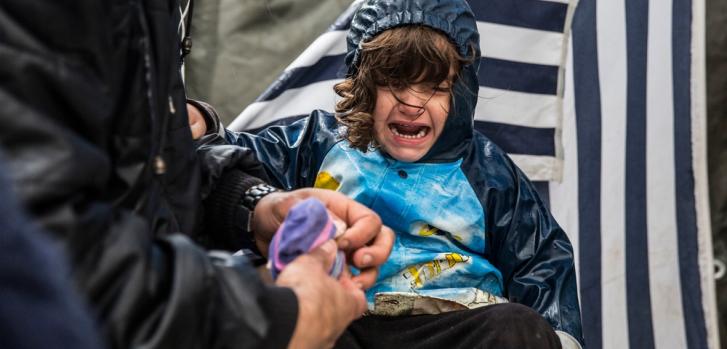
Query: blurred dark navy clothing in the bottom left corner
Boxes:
[{"xmin": 0, "ymin": 158, "xmax": 102, "ymax": 349}]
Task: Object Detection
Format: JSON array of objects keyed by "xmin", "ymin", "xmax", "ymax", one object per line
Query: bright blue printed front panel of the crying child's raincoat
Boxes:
[{"xmin": 316, "ymin": 141, "xmax": 502, "ymax": 302}]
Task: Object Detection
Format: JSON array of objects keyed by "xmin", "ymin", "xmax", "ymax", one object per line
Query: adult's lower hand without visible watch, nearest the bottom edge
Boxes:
[{"xmin": 275, "ymin": 241, "xmax": 366, "ymax": 348}]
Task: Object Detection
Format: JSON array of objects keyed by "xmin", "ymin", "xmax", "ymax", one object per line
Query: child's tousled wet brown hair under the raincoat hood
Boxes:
[{"xmin": 333, "ymin": 25, "xmax": 474, "ymax": 152}]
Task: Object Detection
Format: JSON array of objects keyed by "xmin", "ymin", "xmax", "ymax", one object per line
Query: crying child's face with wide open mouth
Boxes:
[{"xmin": 373, "ymin": 74, "xmax": 453, "ymax": 162}]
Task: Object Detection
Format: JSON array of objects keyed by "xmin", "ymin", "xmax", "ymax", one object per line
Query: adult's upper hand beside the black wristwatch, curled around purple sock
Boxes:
[{"xmin": 252, "ymin": 188, "xmax": 394, "ymax": 288}]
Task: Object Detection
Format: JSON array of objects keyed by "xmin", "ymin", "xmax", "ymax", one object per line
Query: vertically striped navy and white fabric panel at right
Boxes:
[{"xmin": 550, "ymin": 0, "xmax": 719, "ymax": 348}]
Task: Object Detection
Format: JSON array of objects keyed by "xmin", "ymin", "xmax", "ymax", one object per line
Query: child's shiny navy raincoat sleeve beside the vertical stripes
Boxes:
[{"xmin": 486, "ymin": 155, "xmax": 582, "ymax": 343}]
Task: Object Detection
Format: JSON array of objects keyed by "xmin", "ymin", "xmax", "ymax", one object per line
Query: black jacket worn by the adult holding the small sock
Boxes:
[{"xmin": 0, "ymin": 0, "xmax": 297, "ymax": 348}]
